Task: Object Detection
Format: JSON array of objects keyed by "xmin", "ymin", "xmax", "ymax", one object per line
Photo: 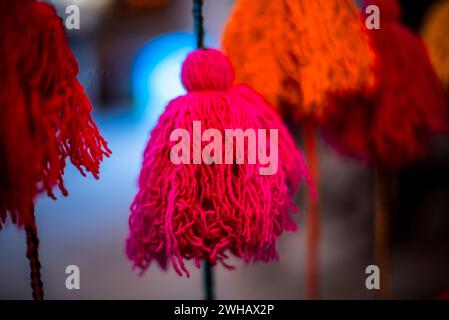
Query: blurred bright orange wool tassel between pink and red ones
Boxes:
[{"xmin": 223, "ymin": 0, "xmax": 373, "ymax": 120}]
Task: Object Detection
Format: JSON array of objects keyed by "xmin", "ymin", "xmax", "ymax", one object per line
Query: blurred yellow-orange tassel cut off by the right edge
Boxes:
[{"xmin": 422, "ymin": 0, "xmax": 449, "ymax": 95}]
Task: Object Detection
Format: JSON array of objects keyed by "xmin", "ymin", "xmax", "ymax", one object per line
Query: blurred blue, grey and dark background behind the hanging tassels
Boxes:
[{"xmin": 0, "ymin": 0, "xmax": 449, "ymax": 299}]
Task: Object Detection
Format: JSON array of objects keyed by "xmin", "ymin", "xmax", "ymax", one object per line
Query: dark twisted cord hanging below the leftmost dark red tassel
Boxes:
[{"xmin": 25, "ymin": 206, "xmax": 44, "ymax": 300}]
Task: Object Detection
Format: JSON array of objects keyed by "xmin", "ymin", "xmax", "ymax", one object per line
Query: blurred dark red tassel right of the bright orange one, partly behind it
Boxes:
[{"xmin": 323, "ymin": 0, "xmax": 448, "ymax": 168}]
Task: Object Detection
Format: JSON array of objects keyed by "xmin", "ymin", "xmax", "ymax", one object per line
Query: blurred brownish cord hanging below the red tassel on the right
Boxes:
[{"xmin": 374, "ymin": 169, "xmax": 390, "ymax": 299}]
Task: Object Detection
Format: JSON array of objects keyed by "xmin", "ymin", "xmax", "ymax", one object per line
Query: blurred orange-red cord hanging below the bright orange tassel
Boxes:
[{"xmin": 304, "ymin": 123, "xmax": 320, "ymax": 300}]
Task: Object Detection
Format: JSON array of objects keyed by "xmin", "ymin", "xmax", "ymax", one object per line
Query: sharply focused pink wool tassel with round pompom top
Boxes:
[{"xmin": 127, "ymin": 49, "xmax": 311, "ymax": 276}]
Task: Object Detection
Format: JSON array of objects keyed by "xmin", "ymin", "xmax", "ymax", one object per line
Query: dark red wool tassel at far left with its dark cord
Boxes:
[{"xmin": 0, "ymin": 0, "xmax": 110, "ymax": 299}]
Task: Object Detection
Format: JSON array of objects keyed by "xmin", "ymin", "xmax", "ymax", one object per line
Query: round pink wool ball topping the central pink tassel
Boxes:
[{"xmin": 181, "ymin": 49, "xmax": 234, "ymax": 92}]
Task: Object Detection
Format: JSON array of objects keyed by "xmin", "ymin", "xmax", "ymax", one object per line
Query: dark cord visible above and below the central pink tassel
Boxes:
[{"xmin": 192, "ymin": 0, "xmax": 215, "ymax": 300}]
